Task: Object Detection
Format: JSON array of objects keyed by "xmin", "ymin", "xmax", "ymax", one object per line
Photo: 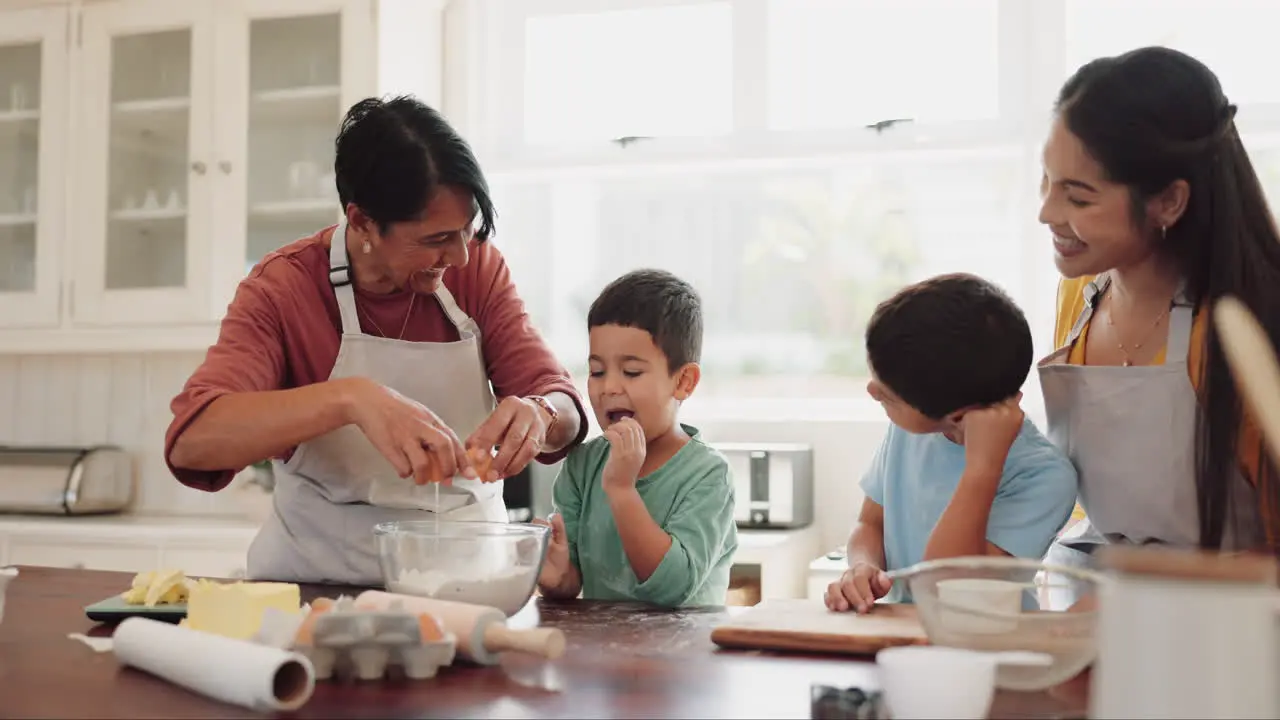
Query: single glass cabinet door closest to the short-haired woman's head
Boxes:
[{"xmin": 214, "ymin": 0, "xmax": 360, "ymax": 310}]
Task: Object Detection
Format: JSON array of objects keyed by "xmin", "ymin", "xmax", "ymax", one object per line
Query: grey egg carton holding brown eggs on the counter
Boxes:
[{"xmin": 294, "ymin": 601, "xmax": 457, "ymax": 680}]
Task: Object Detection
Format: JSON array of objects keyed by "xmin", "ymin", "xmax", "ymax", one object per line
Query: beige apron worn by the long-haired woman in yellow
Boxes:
[{"xmin": 1038, "ymin": 274, "xmax": 1261, "ymax": 565}]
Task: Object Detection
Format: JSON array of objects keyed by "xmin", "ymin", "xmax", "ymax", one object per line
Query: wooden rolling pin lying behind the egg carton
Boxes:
[{"xmin": 356, "ymin": 591, "xmax": 564, "ymax": 665}]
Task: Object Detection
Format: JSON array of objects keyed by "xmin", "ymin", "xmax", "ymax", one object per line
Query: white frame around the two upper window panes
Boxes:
[{"xmin": 474, "ymin": 0, "xmax": 1039, "ymax": 167}]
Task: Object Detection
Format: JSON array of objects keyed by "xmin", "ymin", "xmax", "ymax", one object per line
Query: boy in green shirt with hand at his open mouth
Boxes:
[{"xmin": 538, "ymin": 270, "xmax": 737, "ymax": 607}]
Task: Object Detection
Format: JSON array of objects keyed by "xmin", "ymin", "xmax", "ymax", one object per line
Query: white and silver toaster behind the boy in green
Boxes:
[{"xmin": 712, "ymin": 442, "xmax": 813, "ymax": 529}]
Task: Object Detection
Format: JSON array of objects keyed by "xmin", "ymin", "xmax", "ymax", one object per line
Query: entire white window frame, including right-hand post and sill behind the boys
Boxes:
[{"xmin": 444, "ymin": 0, "xmax": 1280, "ymax": 420}]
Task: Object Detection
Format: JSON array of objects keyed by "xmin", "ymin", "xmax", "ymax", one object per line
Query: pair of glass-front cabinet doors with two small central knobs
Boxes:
[{"xmin": 73, "ymin": 0, "xmax": 371, "ymax": 325}]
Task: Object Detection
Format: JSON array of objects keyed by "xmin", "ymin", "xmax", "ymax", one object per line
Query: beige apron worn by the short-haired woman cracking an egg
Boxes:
[{"xmin": 247, "ymin": 220, "xmax": 507, "ymax": 585}]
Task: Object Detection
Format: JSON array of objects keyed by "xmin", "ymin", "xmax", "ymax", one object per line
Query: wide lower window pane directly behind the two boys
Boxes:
[{"xmin": 494, "ymin": 149, "xmax": 1033, "ymax": 397}]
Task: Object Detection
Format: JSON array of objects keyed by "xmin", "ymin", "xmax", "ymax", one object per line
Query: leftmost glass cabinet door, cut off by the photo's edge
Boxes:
[{"xmin": 0, "ymin": 9, "xmax": 69, "ymax": 327}]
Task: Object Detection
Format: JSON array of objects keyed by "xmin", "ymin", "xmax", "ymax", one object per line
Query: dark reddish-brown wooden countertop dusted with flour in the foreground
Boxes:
[{"xmin": 0, "ymin": 568, "xmax": 1083, "ymax": 719}]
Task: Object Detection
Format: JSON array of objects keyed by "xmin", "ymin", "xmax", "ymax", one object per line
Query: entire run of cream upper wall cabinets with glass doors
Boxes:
[{"xmin": 0, "ymin": 0, "xmax": 444, "ymax": 345}]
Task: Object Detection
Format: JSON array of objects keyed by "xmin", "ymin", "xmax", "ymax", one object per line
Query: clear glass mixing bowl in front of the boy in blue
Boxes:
[{"xmin": 891, "ymin": 557, "xmax": 1105, "ymax": 691}]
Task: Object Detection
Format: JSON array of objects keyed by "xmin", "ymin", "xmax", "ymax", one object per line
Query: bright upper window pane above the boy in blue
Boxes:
[{"xmin": 765, "ymin": 0, "xmax": 1000, "ymax": 132}]
